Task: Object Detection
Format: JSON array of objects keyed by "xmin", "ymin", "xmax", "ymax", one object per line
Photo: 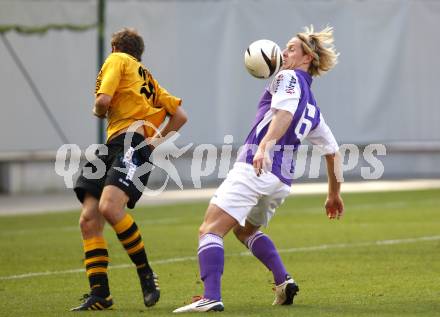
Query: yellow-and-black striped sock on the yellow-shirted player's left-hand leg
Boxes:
[{"xmin": 83, "ymin": 237, "xmax": 110, "ymax": 298}]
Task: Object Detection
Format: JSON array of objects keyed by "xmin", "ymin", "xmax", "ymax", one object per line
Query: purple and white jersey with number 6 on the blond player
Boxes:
[{"xmin": 237, "ymin": 70, "xmax": 326, "ymax": 186}]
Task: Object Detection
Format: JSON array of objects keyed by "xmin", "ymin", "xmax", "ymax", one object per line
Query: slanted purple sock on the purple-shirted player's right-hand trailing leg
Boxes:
[{"xmin": 246, "ymin": 231, "xmax": 288, "ymax": 285}]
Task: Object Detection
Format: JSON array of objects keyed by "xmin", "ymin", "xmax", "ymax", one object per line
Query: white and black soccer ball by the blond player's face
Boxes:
[{"xmin": 244, "ymin": 40, "xmax": 283, "ymax": 78}]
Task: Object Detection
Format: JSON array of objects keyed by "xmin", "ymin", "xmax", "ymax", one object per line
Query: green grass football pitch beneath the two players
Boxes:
[{"xmin": 0, "ymin": 190, "xmax": 440, "ymax": 316}]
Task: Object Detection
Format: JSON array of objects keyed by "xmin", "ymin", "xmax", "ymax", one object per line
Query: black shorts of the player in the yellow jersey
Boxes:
[{"xmin": 74, "ymin": 133, "xmax": 152, "ymax": 209}]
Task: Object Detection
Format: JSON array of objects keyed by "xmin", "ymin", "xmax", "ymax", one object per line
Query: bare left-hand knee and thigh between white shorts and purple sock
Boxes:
[{"xmin": 199, "ymin": 204, "xmax": 238, "ymax": 237}]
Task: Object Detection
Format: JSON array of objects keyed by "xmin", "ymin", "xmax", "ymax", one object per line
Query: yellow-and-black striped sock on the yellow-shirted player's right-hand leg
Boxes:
[{"xmin": 113, "ymin": 214, "xmax": 152, "ymax": 274}]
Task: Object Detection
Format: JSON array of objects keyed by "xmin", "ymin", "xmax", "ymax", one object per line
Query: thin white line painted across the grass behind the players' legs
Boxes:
[{"xmin": 0, "ymin": 236, "xmax": 440, "ymax": 281}]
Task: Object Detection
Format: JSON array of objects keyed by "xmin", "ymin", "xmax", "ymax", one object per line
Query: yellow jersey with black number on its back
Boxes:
[{"xmin": 95, "ymin": 52, "xmax": 182, "ymax": 140}]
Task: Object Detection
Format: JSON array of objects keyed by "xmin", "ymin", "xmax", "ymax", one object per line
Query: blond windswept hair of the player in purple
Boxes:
[{"xmin": 296, "ymin": 25, "xmax": 339, "ymax": 76}]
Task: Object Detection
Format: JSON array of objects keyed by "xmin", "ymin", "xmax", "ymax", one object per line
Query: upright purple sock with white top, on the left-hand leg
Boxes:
[{"xmin": 198, "ymin": 233, "xmax": 225, "ymax": 301}]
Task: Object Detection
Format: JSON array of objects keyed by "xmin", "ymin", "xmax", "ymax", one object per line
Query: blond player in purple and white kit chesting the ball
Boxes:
[{"xmin": 174, "ymin": 26, "xmax": 344, "ymax": 313}]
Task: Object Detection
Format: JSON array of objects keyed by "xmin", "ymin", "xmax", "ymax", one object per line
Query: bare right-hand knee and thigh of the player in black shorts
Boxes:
[{"xmin": 99, "ymin": 185, "xmax": 129, "ymax": 225}]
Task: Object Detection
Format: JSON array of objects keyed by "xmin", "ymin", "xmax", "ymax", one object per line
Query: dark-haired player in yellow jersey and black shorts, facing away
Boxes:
[{"xmin": 72, "ymin": 28, "xmax": 187, "ymax": 311}]
